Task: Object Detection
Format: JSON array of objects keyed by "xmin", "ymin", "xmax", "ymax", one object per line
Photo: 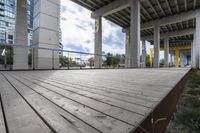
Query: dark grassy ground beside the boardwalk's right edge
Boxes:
[{"xmin": 166, "ymin": 70, "xmax": 200, "ymax": 133}]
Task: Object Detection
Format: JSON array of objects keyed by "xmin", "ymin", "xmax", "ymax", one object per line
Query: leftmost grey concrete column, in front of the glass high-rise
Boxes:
[{"xmin": 13, "ymin": 0, "xmax": 28, "ymax": 70}]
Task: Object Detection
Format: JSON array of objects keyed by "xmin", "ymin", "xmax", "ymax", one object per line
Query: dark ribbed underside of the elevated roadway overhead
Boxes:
[{"xmin": 72, "ymin": 0, "xmax": 200, "ymax": 43}]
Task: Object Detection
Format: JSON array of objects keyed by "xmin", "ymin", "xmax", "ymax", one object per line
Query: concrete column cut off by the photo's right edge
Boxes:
[{"xmin": 195, "ymin": 15, "xmax": 200, "ymax": 68}]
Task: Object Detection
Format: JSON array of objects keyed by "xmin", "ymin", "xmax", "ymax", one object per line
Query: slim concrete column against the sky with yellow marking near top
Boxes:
[{"xmin": 94, "ymin": 17, "xmax": 102, "ymax": 68}]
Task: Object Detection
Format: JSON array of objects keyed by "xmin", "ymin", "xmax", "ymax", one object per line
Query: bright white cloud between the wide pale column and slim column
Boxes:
[{"xmin": 61, "ymin": 0, "xmax": 94, "ymax": 51}]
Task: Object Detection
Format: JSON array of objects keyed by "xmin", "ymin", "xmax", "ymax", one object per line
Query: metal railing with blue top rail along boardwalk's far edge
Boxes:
[{"xmin": 0, "ymin": 44, "xmax": 124, "ymax": 70}]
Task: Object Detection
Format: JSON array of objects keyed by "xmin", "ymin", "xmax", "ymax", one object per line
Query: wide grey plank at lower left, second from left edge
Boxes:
[{"xmin": 0, "ymin": 74, "xmax": 50, "ymax": 133}]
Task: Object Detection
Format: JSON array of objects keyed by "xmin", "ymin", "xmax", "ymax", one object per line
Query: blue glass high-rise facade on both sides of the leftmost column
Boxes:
[{"xmin": 0, "ymin": 0, "xmax": 33, "ymax": 45}]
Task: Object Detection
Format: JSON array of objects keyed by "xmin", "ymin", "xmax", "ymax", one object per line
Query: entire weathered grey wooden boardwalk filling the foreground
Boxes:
[{"xmin": 0, "ymin": 69, "xmax": 189, "ymax": 133}]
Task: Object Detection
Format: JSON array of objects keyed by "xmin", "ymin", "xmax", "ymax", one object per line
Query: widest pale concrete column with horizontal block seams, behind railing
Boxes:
[{"xmin": 33, "ymin": 0, "xmax": 60, "ymax": 69}]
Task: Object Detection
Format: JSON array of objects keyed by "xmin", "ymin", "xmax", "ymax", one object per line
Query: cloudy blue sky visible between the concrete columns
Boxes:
[{"xmin": 61, "ymin": 0, "xmax": 160, "ymax": 57}]
